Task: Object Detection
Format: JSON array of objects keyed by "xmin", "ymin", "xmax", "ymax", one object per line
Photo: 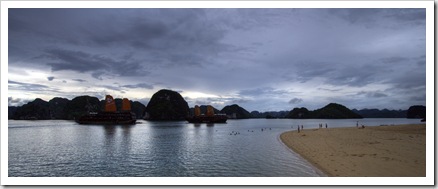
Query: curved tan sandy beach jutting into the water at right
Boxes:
[{"xmin": 280, "ymin": 124, "xmax": 426, "ymax": 177}]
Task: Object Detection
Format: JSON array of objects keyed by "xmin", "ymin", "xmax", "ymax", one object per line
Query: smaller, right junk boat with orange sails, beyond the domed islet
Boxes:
[{"xmin": 186, "ymin": 105, "xmax": 228, "ymax": 123}]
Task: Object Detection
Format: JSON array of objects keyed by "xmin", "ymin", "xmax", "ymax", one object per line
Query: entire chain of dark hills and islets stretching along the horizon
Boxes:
[{"xmin": 8, "ymin": 89, "xmax": 426, "ymax": 120}]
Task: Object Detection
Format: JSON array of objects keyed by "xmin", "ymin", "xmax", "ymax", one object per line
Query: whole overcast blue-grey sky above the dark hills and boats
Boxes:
[{"xmin": 8, "ymin": 9, "xmax": 426, "ymax": 111}]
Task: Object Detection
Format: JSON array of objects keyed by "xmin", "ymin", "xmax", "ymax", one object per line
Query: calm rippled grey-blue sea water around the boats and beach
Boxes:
[{"xmin": 8, "ymin": 119, "xmax": 420, "ymax": 177}]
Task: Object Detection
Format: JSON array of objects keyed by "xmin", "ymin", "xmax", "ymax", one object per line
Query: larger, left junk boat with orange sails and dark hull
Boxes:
[{"xmin": 75, "ymin": 95, "xmax": 137, "ymax": 124}]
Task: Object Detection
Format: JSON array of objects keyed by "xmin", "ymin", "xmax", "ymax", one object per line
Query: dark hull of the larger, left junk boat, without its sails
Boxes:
[{"xmin": 76, "ymin": 112, "xmax": 137, "ymax": 125}]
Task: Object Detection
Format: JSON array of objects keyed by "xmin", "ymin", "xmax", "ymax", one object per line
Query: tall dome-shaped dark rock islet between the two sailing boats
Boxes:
[{"xmin": 146, "ymin": 89, "xmax": 190, "ymax": 120}]
